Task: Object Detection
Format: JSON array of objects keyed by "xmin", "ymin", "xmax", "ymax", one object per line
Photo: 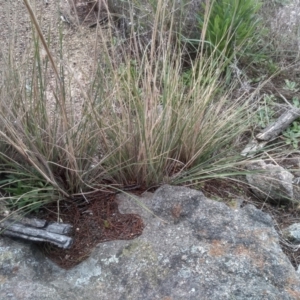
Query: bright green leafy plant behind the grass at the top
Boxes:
[{"xmin": 193, "ymin": 0, "xmax": 261, "ymax": 64}]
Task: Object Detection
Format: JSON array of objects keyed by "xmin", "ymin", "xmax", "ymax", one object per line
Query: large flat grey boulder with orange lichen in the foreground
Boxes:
[{"xmin": 0, "ymin": 185, "xmax": 300, "ymax": 300}]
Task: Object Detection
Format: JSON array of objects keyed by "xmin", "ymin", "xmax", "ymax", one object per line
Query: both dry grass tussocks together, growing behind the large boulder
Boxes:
[{"xmin": 0, "ymin": 0, "xmax": 260, "ymax": 218}]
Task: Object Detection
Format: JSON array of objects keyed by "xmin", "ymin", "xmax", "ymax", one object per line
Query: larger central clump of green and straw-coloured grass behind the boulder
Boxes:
[{"xmin": 97, "ymin": 39, "xmax": 255, "ymax": 186}]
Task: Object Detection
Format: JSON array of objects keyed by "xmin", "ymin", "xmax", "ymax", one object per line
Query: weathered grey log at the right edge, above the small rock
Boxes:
[{"xmin": 256, "ymin": 107, "xmax": 300, "ymax": 141}]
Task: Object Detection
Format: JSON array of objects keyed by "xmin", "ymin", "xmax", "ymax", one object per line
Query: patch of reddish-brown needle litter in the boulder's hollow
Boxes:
[{"xmin": 39, "ymin": 193, "xmax": 144, "ymax": 269}]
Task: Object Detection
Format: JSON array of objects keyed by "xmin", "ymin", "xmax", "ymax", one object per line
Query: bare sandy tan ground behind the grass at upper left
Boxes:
[{"xmin": 0, "ymin": 0, "xmax": 110, "ymax": 115}]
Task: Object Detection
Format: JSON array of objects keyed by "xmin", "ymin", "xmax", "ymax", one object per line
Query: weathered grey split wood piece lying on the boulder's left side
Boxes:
[{"xmin": 0, "ymin": 218, "xmax": 73, "ymax": 249}]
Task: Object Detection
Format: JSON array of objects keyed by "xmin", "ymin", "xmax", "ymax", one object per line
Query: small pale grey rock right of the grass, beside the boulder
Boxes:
[{"xmin": 246, "ymin": 161, "xmax": 300, "ymax": 201}]
